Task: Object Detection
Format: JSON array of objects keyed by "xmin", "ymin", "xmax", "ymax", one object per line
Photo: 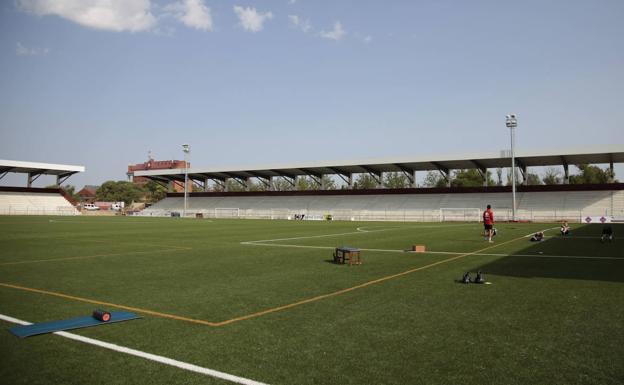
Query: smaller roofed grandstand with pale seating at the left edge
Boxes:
[{"xmin": 0, "ymin": 160, "xmax": 85, "ymax": 215}]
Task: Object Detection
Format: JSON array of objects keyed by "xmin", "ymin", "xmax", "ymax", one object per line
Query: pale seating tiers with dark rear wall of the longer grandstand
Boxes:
[{"xmin": 140, "ymin": 183, "xmax": 624, "ymax": 222}]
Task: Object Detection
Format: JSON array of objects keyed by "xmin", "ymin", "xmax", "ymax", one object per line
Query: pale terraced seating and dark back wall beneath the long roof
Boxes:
[{"xmin": 141, "ymin": 190, "xmax": 624, "ymax": 221}]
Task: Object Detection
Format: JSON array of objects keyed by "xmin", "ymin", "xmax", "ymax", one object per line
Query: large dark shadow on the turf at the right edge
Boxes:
[{"xmin": 472, "ymin": 225, "xmax": 624, "ymax": 282}]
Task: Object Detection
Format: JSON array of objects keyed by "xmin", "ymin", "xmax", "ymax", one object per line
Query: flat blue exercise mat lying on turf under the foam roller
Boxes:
[{"xmin": 9, "ymin": 311, "xmax": 141, "ymax": 338}]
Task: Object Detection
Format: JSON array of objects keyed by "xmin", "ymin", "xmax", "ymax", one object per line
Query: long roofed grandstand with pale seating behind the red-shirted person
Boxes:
[{"xmin": 136, "ymin": 147, "xmax": 624, "ymax": 222}]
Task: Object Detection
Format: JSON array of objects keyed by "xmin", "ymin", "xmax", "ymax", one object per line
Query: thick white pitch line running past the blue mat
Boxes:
[{"xmin": 0, "ymin": 314, "xmax": 267, "ymax": 385}]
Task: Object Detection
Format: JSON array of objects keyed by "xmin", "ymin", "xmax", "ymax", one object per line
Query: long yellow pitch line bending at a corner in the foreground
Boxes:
[{"xmin": 0, "ymin": 229, "xmax": 549, "ymax": 327}]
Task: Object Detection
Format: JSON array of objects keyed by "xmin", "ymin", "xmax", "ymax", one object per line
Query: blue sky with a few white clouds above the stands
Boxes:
[{"xmin": 0, "ymin": 0, "xmax": 624, "ymax": 187}]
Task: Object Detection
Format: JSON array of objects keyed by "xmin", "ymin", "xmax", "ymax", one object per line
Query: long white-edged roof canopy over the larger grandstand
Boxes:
[{"xmin": 134, "ymin": 145, "xmax": 624, "ymax": 188}]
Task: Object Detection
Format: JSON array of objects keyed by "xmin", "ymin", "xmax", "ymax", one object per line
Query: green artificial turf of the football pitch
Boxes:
[{"xmin": 0, "ymin": 217, "xmax": 624, "ymax": 385}]
